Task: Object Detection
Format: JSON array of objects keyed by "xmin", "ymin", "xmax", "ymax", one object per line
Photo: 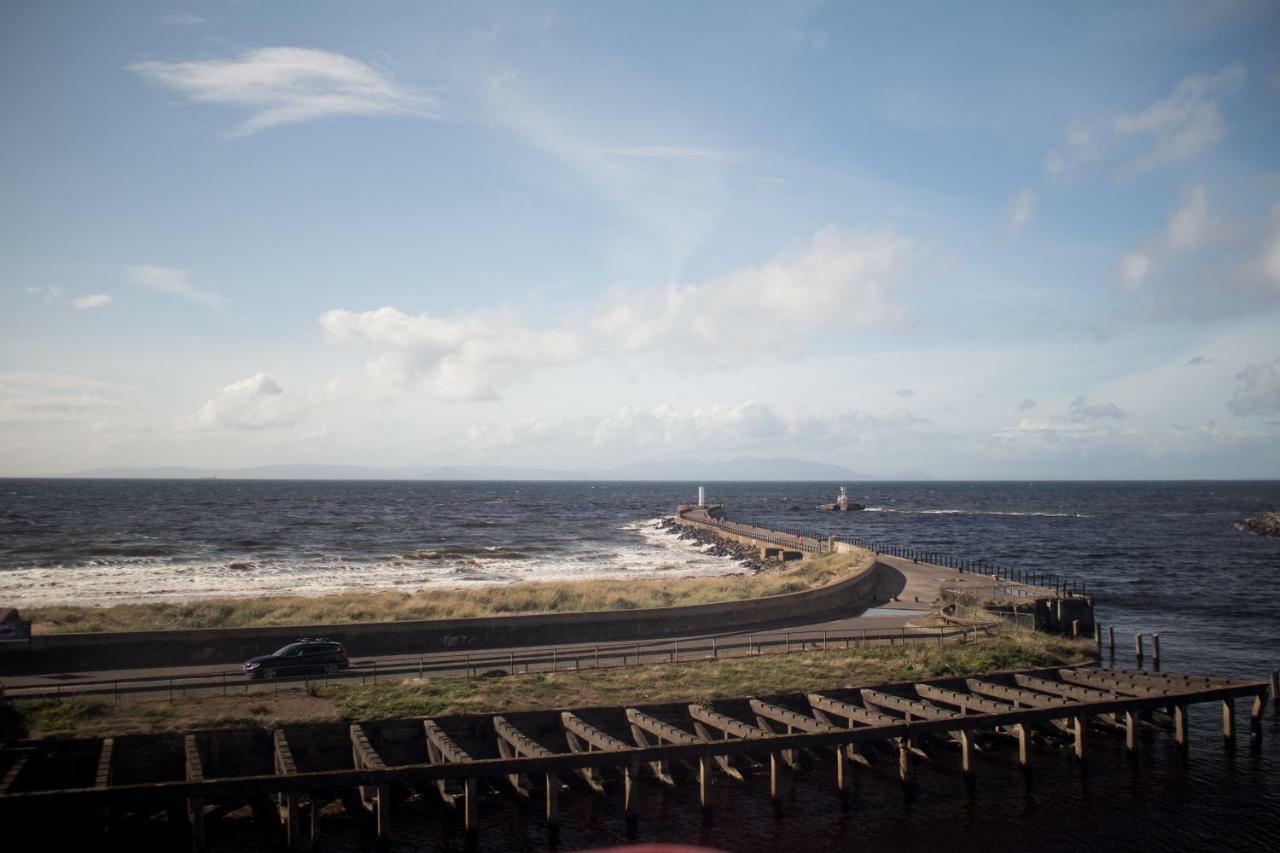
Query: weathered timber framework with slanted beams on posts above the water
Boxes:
[{"xmin": 0, "ymin": 667, "xmax": 1268, "ymax": 852}]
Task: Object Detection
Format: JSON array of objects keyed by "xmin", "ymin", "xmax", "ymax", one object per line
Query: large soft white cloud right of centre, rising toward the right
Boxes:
[{"xmin": 591, "ymin": 225, "xmax": 915, "ymax": 353}]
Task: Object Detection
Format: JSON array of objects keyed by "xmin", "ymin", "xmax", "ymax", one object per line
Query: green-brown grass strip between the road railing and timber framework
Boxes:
[{"xmin": 0, "ymin": 634, "xmax": 1092, "ymax": 736}]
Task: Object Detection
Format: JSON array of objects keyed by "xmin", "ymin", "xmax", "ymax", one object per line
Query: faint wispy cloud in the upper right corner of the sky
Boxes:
[{"xmin": 1044, "ymin": 64, "xmax": 1244, "ymax": 177}]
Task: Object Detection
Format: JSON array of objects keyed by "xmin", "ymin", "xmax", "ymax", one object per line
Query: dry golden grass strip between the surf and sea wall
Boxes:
[{"xmin": 24, "ymin": 552, "xmax": 872, "ymax": 634}]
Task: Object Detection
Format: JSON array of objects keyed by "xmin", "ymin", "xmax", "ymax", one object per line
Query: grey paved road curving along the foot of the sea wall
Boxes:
[{"xmin": 4, "ymin": 556, "xmax": 1018, "ymax": 695}]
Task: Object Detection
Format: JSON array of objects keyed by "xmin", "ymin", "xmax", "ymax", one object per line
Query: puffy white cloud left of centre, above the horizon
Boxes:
[{"xmin": 320, "ymin": 307, "xmax": 581, "ymax": 400}]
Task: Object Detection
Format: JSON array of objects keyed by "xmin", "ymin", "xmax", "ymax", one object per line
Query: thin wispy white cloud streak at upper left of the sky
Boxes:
[{"xmin": 129, "ymin": 47, "xmax": 439, "ymax": 136}]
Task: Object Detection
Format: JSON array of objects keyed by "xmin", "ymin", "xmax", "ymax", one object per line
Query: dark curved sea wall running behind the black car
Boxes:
[{"xmin": 0, "ymin": 555, "xmax": 876, "ymax": 675}]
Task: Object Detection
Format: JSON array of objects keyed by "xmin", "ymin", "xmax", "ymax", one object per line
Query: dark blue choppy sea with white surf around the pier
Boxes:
[{"xmin": 0, "ymin": 479, "xmax": 1280, "ymax": 852}]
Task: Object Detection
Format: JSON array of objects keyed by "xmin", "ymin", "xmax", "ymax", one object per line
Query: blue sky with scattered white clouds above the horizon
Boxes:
[{"xmin": 0, "ymin": 1, "xmax": 1280, "ymax": 479}]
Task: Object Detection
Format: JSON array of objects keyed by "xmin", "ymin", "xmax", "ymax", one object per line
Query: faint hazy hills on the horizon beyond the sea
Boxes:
[{"xmin": 68, "ymin": 456, "xmax": 931, "ymax": 483}]
